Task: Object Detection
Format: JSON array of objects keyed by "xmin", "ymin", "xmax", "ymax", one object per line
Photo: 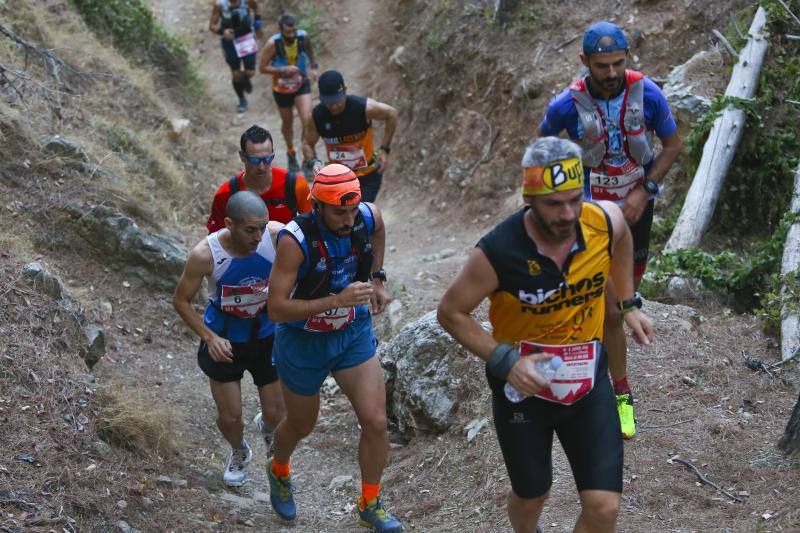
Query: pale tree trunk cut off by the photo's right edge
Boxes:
[{"xmin": 781, "ymin": 165, "xmax": 800, "ymax": 361}]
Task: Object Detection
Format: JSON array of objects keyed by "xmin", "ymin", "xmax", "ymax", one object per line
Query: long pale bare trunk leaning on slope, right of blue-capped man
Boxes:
[{"xmin": 664, "ymin": 7, "xmax": 769, "ymax": 252}]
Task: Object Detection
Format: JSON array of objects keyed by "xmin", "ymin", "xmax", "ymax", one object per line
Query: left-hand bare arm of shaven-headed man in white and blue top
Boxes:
[{"xmin": 172, "ymin": 240, "xmax": 233, "ymax": 362}]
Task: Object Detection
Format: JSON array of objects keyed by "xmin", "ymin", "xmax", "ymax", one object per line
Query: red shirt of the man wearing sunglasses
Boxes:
[{"xmin": 206, "ymin": 167, "xmax": 311, "ymax": 233}]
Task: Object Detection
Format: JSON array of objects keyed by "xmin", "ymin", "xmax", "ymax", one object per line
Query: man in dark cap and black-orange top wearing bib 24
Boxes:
[{"xmin": 303, "ymin": 70, "xmax": 397, "ymax": 202}]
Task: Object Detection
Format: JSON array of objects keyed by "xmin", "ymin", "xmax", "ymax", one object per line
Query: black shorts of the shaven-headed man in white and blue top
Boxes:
[{"xmin": 197, "ymin": 335, "xmax": 278, "ymax": 387}]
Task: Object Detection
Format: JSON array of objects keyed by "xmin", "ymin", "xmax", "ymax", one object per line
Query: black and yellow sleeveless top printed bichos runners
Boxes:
[{"xmin": 478, "ymin": 203, "xmax": 612, "ymax": 344}]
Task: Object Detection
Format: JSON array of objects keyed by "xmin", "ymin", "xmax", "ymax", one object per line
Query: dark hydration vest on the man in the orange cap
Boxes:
[{"xmin": 286, "ymin": 209, "xmax": 374, "ymax": 300}]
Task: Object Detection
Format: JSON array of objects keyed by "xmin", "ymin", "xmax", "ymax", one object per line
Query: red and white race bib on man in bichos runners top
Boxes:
[{"xmin": 519, "ymin": 341, "xmax": 600, "ymax": 405}]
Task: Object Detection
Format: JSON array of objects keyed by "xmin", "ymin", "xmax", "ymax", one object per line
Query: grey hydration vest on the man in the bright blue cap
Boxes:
[{"xmin": 569, "ymin": 70, "xmax": 655, "ymax": 168}]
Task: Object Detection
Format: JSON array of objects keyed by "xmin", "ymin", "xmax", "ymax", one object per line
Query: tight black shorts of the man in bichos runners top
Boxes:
[{"xmin": 486, "ymin": 350, "xmax": 623, "ymax": 499}]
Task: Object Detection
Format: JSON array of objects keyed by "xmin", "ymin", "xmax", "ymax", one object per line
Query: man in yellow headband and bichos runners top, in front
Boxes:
[{"xmin": 439, "ymin": 137, "xmax": 653, "ymax": 533}]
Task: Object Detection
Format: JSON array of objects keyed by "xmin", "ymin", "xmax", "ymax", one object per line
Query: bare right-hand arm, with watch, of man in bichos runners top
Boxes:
[{"xmin": 598, "ymin": 202, "xmax": 653, "ymax": 345}]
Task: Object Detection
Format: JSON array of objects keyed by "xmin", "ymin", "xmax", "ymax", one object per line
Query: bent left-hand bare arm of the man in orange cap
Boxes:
[{"xmin": 267, "ymin": 235, "xmax": 372, "ymax": 322}]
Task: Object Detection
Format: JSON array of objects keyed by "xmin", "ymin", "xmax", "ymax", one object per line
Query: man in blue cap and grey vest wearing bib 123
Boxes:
[{"xmin": 539, "ymin": 21, "xmax": 683, "ymax": 438}]
